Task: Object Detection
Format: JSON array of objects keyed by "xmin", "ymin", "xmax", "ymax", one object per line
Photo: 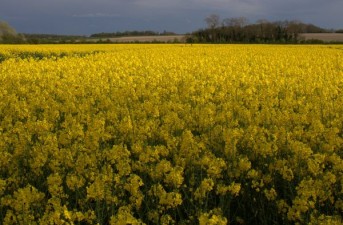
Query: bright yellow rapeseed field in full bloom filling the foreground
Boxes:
[{"xmin": 0, "ymin": 44, "xmax": 343, "ymax": 225}]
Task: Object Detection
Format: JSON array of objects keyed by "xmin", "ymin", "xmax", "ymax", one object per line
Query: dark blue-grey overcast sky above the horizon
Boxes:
[{"xmin": 0, "ymin": 0, "xmax": 343, "ymax": 35}]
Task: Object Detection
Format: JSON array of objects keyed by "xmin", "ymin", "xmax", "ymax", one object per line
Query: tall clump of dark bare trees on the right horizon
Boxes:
[{"xmin": 187, "ymin": 15, "xmax": 342, "ymax": 43}]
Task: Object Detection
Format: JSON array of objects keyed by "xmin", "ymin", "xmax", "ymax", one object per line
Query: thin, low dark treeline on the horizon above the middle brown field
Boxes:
[{"xmin": 90, "ymin": 30, "xmax": 175, "ymax": 38}]
